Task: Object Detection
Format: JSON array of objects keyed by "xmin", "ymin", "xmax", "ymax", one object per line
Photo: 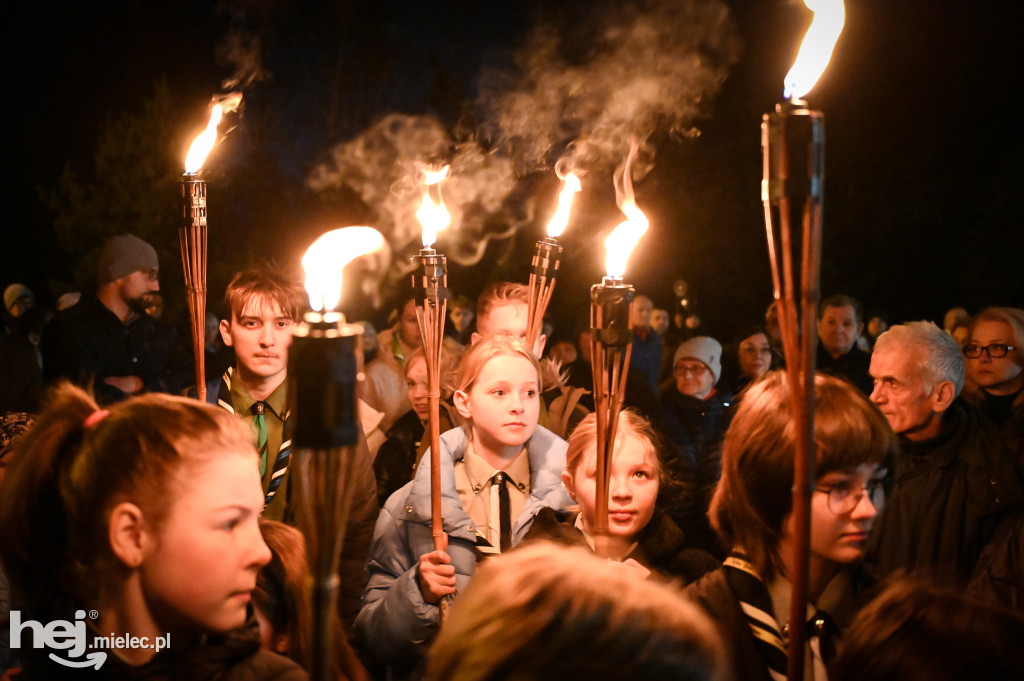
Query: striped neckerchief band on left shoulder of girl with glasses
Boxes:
[{"xmin": 722, "ymin": 553, "xmax": 786, "ymax": 681}]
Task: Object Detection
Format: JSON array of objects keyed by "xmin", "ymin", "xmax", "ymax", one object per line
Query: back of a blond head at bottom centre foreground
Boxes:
[{"xmin": 427, "ymin": 542, "xmax": 727, "ymax": 681}]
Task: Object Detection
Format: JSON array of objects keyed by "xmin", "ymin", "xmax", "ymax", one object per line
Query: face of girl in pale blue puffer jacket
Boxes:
[{"xmin": 455, "ymin": 354, "xmax": 541, "ymax": 452}]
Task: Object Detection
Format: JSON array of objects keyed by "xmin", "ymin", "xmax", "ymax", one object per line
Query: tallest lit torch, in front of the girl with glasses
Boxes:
[{"xmin": 761, "ymin": 0, "xmax": 845, "ymax": 681}]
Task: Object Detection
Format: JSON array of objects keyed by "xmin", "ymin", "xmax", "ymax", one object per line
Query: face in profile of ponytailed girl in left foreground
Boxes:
[{"xmin": 139, "ymin": 450, "xmax": 270, "ymax": 632}]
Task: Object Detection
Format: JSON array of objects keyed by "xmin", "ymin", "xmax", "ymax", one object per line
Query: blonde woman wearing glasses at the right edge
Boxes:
[{"xmin": 964, "ymin": 307, "xmax": 1024, "ymax": 465}]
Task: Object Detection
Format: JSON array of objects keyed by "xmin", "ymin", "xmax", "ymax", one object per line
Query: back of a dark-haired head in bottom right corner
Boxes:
[{"xmin": 828, "ymin": 577, "xmax": 1024, "ymax": 681}]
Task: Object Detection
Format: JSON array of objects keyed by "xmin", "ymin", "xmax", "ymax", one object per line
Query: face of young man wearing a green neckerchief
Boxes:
[{"xmin": 220, "ymin": 298, "xmax": 295, "ymax": 380}]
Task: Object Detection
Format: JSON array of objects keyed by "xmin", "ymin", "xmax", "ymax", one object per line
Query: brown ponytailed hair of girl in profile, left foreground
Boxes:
[{"xmin": 0, "ymin": 383, "xmax": 256, "ymax": 619}]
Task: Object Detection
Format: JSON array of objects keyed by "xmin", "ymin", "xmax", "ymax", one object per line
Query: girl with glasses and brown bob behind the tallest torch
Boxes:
[{"xmin": 687, "ymin": 372, "xmax": 896, "ymax": 681}]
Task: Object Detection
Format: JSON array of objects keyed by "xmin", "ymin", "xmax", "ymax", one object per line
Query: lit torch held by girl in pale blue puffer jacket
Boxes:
[{"xmin": 413, "ymin": 166, "xmax": 452, "ymax": 557}]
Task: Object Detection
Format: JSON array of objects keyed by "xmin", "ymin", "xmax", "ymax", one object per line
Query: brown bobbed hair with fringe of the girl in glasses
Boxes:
[{"xmin": 708, "ymin": 372, "xmax": 896, "ymax": 580}]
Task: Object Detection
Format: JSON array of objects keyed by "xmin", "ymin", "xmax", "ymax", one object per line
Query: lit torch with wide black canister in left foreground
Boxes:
[{"xmin": 288, "ymin": 227, "xmax": 384, "ymax": 681}]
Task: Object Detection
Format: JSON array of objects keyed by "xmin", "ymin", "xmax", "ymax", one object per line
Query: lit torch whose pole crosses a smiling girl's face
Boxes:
[{"xmin": 590, "ymin": 141, "xmax": 648, "ymax": 556}]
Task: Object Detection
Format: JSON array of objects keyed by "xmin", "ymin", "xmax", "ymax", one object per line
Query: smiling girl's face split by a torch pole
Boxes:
[{"xmin": 562, "ymin": 432, "xmax": 659, "ymax": 542}]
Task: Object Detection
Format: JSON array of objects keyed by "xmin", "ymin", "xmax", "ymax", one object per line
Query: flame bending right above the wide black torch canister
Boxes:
[{"xmin": 302, "ymin": 227, "xmax": 384, "ymax": 311}]
